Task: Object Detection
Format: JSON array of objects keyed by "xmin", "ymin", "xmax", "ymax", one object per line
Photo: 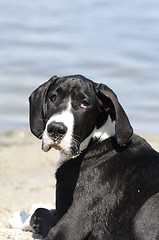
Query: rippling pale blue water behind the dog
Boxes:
[{"xmin": 0, "ymin": 0, "xmax": 159, "ymax": 134}]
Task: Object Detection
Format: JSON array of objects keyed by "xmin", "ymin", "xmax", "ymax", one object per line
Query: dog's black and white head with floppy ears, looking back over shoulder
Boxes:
[{"xmin": 29, "ymin": 75, "xmax": 133, "ymax": 157}]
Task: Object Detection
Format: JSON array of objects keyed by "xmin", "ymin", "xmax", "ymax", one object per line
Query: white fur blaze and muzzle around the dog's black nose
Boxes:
[{"xmin": 42, "ymin": 100, "xmax": 74, "ymax": 155}]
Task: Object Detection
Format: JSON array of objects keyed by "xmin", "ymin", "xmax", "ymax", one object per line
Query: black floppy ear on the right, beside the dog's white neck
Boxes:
[{"xmin": 97, "ymin": 84, "xmax": 133, "ymax": 146}]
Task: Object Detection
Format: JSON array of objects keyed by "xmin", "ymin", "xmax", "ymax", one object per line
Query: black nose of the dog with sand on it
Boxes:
[{"xmin": 47, "ymin": 122, "xmax": 67, "ymax": 141}]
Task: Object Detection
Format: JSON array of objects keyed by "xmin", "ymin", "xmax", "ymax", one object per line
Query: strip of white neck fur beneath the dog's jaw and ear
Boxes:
[{"xmin": 56, "ymin": 116, "xmax": 115, "ymax": 169}]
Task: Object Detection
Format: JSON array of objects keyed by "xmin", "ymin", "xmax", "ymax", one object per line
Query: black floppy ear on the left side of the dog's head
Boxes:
[{"xmin": 29, "ymin": 76, "xmax": 57, "ymax": 139}]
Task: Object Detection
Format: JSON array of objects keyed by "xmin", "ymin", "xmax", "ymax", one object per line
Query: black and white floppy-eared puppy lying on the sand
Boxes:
[{"xmin": 29, "ymin": 75, "xmax": 159, "ymax": 240}]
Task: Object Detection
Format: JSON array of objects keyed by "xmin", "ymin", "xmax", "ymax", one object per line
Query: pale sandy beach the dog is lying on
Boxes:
[{"xmin": 0, "ymin": 130, "xmax": 159, "ymax": 240}]
